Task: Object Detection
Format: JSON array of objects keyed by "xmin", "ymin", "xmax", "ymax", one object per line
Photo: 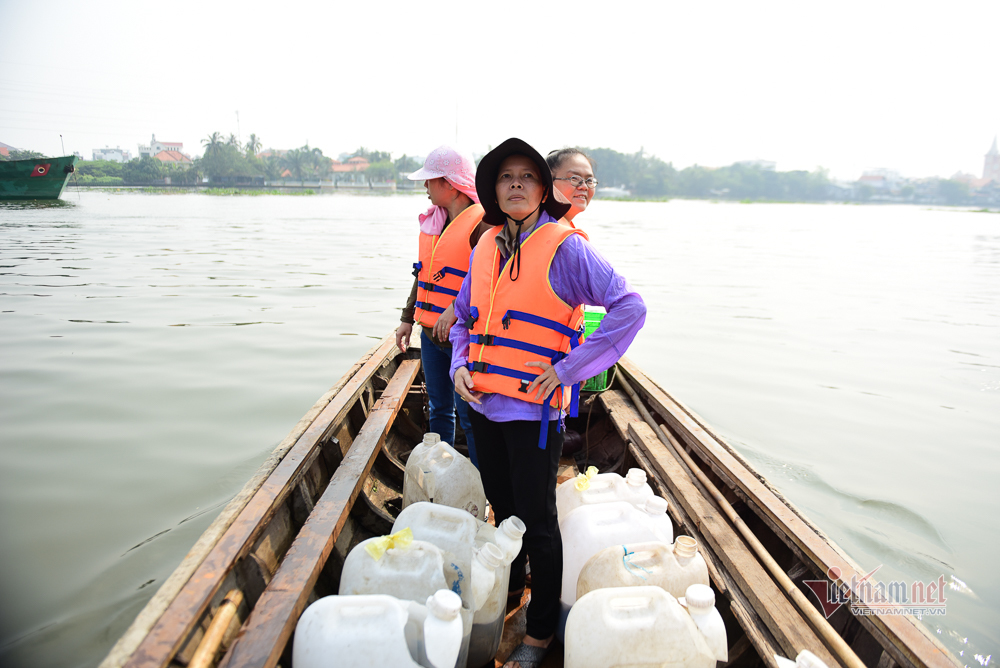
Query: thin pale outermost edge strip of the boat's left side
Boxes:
[{"xmin": 99, "ymin": 334, "xmax": 393, "ymax": 668}]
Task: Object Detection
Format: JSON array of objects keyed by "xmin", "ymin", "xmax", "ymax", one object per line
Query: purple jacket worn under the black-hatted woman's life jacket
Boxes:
[{"xmin": 448, "ymin": 211, "xmax": 646, "ymax": 422}]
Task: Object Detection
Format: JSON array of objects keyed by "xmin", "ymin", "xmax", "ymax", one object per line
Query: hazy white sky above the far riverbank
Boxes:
[{"xmin": 0, "ymin": 0, "xmax": 1000, "ymax": 179}]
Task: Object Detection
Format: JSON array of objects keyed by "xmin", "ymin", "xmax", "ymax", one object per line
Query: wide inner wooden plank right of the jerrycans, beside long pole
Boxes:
[{"xmin": 629, "ymin": 422, "xmax": 840, "ymax": 666}]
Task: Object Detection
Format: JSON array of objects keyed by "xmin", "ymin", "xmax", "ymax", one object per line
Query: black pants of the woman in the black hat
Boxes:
[{"xmin": 469, "ymin": 410, "xmax": 563, "ymax": 639}]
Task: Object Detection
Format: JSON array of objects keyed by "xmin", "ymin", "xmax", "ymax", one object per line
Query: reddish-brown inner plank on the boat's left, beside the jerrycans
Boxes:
[{"xmin": 223, "ymin": 360, "xmax": 420, "ymax": 668}]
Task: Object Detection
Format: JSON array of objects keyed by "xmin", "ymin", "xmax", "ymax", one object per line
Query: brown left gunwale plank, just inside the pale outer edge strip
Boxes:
[{"xmin": 125, "ymin": 337, "xmax": 398, "ymax": 668}]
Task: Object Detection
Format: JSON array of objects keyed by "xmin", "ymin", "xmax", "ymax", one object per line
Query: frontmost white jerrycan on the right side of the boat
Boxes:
[{"xmin": 564, "ymin": 587, "xmax": 728, "ymax": 668}]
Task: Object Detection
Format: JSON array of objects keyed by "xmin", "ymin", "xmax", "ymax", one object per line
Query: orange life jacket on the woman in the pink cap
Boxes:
[{"xmin": 413, "ymin": 204, "xmax": 483, "ymax": 327}]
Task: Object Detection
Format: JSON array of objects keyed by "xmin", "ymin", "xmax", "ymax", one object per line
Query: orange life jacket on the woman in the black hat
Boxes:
[{"xmin": 465, "ymin": 223, "xmax": 587, "ymax": 426}]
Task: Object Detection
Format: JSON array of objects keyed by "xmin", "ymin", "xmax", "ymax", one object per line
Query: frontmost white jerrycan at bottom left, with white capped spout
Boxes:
[{"xmin": 292, "ymin": 590, "xmax": 462, "ymax": 668}]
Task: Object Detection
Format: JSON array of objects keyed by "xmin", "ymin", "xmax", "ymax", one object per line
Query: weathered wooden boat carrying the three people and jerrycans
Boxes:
[{"xmin": 101, "ymin": 336, "xmax": 958, "ymax": 668}]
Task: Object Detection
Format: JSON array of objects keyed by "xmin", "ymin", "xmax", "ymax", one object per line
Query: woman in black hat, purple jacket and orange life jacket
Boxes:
[{"xmin": 450, "ymin": 139, "xmax": 646, "ymax": 668}]
